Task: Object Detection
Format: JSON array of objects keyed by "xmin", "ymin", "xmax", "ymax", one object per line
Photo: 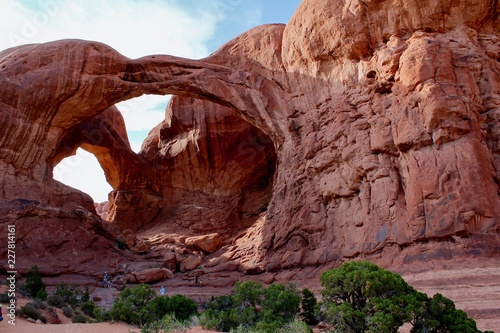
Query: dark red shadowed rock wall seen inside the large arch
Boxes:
[{"xmin": 111, "ymin": 92, "xmax": 277, "ymax": 234}]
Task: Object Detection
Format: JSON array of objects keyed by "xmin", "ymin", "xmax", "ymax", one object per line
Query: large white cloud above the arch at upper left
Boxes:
[{"xmin": 0, "ymin": 0, "xmax": 220, "ymax": 58}]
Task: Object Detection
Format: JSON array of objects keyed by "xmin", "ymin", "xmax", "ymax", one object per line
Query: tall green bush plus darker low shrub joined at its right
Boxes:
[{"xmin": 321, "ymin": 261, "xmax": 488, "ymax": 333}]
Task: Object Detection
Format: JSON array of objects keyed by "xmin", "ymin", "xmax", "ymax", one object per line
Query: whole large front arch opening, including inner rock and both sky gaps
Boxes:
[{"xmin": 48, "ymin": 89, "xmax": 277, "ymax": 236}]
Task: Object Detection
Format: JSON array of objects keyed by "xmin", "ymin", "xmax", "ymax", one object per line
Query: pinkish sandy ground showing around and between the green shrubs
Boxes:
[{"xmin": 0, "ymin": 254, "xmax": 500, "ymax": 333}]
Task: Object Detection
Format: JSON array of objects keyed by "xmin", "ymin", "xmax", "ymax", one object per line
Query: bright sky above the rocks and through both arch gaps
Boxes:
[{"xmin": 0, "ymin": 0, "xmax": 301, "ymax": 202}]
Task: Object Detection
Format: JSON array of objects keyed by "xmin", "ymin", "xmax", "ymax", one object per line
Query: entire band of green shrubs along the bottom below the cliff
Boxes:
[{"xmin": 19, "ymin": 261, "xmax": 492, "ymax": 333}]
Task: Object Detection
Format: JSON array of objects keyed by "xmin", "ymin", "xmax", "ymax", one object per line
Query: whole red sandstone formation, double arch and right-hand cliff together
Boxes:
[{"xmin": 0, "ymin": 0, "xmax": 500, "ymax": 272}]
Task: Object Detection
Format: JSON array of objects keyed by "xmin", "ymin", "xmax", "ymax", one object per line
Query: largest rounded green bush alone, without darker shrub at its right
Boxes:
[{"xmin": 321, "ymin": 261, "xmax": 423, "ymax": 332}]
